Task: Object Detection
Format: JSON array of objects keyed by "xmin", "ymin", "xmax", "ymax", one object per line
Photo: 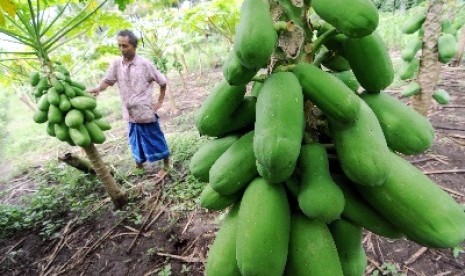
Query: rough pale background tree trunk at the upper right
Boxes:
[{"xmin": 412, "ymin": 0, "xmax": 444, "ymax": 116}]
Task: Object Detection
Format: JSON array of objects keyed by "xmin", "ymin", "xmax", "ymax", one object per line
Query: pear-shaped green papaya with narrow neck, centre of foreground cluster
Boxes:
[{"xmin": 298, "ymin": 143, "xmax": 344, "ymax": 223}]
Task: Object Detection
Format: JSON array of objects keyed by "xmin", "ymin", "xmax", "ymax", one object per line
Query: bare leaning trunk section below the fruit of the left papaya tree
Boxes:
[{"xmin": 83, "ymin": 144, "xmax": 128, "ymax": 209}]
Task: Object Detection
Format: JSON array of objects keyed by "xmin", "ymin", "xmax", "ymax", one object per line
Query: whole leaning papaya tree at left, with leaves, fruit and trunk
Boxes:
[{"xmin": 0, "ymin": 0, "xmax": 127, "ymax": 208}]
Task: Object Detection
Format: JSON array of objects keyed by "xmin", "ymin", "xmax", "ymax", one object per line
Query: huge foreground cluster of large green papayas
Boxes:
[{"xmin": 190, "ymin": 0, "xmax": 465, "ymax": 276}]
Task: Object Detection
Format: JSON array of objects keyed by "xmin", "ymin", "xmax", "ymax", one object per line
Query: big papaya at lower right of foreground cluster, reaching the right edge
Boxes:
[{"xmin": 357, "ymin": 152, "xmax": 465, "ymax": 248}]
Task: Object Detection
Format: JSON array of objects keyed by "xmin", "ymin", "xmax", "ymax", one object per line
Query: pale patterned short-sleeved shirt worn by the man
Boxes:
[{"xmin": 103, "ymin": 55, "xmax": 168, "ymax": 123}]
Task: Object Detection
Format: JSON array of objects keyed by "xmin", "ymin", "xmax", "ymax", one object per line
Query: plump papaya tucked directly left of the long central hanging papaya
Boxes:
[{"xmin": 209, "ymin": 131, "xmax": 258, "ymax": 195}]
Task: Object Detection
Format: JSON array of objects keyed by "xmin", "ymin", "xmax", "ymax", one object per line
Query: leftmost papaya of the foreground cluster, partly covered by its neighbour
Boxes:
[{"xmin": 189, "ymin": 135, "xmax": 238, "ymax": 182}]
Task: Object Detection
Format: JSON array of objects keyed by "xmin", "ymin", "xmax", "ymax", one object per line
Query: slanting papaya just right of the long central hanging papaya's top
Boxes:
[{"xmin": 293, "ymin": 63, "xmax": 360, "ymax": 123}]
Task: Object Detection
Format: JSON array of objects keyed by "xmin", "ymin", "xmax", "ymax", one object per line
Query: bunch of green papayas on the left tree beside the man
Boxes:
[{"xmin": 30, "ymin": 64, "xmax": 110, "ymax": 147}]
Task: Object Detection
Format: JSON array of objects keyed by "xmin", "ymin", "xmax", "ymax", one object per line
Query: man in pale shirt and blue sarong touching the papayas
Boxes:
[{"xmin": 88, "ymin": 30, "xmax": 170, "ymax": 178}]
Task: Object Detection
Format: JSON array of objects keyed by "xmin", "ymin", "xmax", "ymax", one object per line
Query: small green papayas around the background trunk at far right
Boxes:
[{"xmin": 399, "ymin": 8, "xmax": 465, "ymax": 104}]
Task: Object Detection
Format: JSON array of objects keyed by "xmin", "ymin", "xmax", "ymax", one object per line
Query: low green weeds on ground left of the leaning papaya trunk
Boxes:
[{"xmin": 0, "ymin": 162, "xmax": 100, "ymax": 238}]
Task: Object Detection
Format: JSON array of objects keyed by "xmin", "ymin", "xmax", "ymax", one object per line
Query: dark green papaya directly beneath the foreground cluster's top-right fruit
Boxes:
[{"xmin": 343, "ymin": 33, "xmax": 394, "ymax": 93}]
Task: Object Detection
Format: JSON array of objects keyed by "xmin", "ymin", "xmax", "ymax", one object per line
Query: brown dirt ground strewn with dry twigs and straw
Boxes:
[{"xmin": 0, "ymin": 65, "xmax": 465, "ymax": 276}]
